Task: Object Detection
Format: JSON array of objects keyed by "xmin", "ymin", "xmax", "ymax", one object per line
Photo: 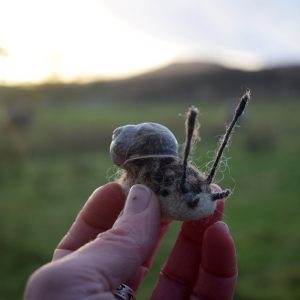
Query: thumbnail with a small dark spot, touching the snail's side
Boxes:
[{"xmin": 124, "ymin": 184, "xmax": 152, "ymax": 215}]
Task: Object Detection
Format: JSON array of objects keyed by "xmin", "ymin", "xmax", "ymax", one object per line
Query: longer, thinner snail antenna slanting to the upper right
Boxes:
[{"xmin": 206, "ymin": 89, "xmax": 251, "ymax": 184}]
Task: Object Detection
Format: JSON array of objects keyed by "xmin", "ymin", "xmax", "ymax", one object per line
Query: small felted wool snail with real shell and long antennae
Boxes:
[{"xmin": 110, "ymin": 90, "xmax": 250, "ymax": 221}]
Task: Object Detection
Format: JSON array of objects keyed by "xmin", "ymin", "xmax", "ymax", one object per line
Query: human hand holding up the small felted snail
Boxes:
[{"xmin": 25, "ymin": 183, "xmax": 237, "ymax": 300}]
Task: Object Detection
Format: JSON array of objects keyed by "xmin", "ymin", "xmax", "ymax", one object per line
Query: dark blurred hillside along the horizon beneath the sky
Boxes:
[{"xmin": 0, "ymin": 62, "xmax": 300, "ymax": 103}]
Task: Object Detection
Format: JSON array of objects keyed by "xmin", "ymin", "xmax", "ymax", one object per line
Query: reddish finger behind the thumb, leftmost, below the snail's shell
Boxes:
[{"xmin": 53, "ymin": 183, "xmax": 125, "ymax": 260}]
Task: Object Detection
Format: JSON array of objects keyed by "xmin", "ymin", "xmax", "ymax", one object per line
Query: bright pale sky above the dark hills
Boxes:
[{"xmin": 0, "ymin": 0, "xmax": 300, "ymax": 85}]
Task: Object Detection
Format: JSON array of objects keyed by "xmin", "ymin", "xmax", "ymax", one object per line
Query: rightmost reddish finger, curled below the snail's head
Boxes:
[{"xmin": 191, "ymin": 222, "xmax": 237, "ymax": 300}]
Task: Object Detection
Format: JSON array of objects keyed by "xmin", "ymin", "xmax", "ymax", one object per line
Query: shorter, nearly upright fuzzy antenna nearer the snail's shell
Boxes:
[{"xmin": 180, "ymin": 106, "xmax": 199, "ymax": 191}]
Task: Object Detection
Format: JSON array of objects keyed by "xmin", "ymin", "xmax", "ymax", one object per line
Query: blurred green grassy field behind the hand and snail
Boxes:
[{"xmin": 0, "ymin": 99, "xmax": 300, "ymax": 300}]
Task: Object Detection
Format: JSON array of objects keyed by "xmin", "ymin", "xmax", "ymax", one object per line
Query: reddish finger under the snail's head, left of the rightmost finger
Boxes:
[{"xmin": 151, "ymin": 197, "xmax": 224, "ymax": 300}]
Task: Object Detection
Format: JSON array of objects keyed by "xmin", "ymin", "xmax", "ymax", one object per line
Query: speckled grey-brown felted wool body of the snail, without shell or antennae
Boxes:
[{"xmin": 118, "ymin": 157, "xmax": 216, "ymax": 221}]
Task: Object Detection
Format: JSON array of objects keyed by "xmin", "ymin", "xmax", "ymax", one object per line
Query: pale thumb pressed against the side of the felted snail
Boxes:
[{"xmin": 71, "ymin": 185, "xmax": 160, "ymax": 292}]
